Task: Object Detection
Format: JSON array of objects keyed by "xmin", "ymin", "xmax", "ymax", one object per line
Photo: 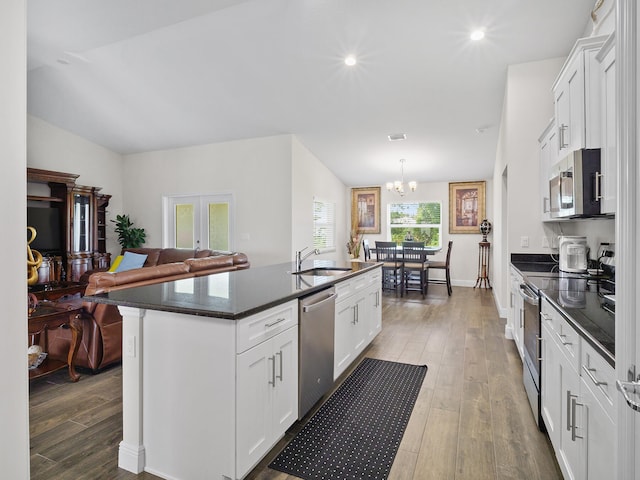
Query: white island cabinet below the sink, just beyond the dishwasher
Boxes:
[{"xmin": 333, "ymin": 268, "xmax": 382, "ymax": 380}]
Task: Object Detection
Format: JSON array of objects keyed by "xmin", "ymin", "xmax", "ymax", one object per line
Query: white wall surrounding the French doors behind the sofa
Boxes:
[{"xmin": 123, "ymin": 135, "xmax": 293, "ymax": 266}]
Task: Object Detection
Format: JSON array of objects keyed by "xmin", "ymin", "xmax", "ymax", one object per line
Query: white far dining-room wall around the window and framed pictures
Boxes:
[{"xmin": 348, "ymin": 178, "xmax": 495, "ymax": 287}]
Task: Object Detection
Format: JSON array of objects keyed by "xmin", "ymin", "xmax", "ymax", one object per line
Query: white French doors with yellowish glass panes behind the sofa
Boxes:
[{"xmin": 163, "ymin": 194, "xmax": 233, "ymax": 251}]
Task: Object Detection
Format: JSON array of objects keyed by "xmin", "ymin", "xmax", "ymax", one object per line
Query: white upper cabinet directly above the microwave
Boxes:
[{"xmin": 553, "ymin": 36, "xmax": 606, "ymax": 158}]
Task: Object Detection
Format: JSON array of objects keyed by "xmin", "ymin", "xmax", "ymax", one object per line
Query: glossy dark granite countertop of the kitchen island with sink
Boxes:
[{"xmin": 85, "ymin": 260, "xmax": 381, "ymax": 320}]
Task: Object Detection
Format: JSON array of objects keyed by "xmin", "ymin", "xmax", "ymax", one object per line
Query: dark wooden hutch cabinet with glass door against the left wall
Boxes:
[{"xmin": 27, "ymin": 168, "xmax": 111, "ymax": 283}]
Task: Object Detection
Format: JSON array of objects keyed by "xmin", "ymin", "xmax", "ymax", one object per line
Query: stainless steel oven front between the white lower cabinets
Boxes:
[{"xmin": 520, "ymin": 284, "xmax": 543, "ymax": 428}]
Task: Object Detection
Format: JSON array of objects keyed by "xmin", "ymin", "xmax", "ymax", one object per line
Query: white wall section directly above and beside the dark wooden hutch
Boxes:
[{"xmin": 27, "ymin": 115, "xmax": 124, "ymax": 258}]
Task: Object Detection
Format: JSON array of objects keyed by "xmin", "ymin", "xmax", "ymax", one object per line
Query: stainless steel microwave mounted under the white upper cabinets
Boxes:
[{"xmin": 549, "ymin": 148, "xmax": 602, "ymax": 218}]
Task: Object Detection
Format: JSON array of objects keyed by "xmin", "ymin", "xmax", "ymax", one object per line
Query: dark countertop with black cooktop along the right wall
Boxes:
[{"xmin": 511, "ymin": 259, "xmax": 615, "ymax": 366}]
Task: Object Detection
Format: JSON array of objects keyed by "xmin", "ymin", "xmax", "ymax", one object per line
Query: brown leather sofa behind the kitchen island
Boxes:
[{"xmin": 49, "ymin": 248, "xmax": 250, "ymax": 372}]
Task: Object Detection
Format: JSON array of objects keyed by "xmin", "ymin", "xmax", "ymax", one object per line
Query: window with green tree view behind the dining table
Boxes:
[{"xmin": 388, "ymin": 202, "xmax": 442, "ymax": 247}]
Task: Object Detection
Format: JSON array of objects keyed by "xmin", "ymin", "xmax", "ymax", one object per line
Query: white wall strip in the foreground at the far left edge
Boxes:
[{"xmin": 0, "ymin": 0, "xmax": 29, "ymax": 480}]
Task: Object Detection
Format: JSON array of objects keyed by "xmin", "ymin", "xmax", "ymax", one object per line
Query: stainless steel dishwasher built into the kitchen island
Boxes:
[{"xmin": 298, "ymin": 287, "xmax": 336, "ymax": 419}]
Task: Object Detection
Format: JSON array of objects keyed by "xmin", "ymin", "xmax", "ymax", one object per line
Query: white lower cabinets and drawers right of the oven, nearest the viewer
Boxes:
[{"xmin": 542, "ymin": 300, "xmax": 616, "ymax": 480}]
